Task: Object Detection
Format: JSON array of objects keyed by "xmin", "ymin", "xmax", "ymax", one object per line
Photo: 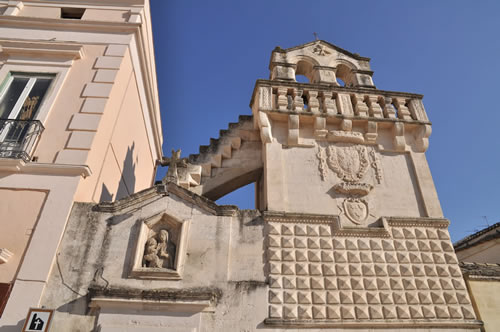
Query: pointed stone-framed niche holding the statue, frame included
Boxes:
[{"xmin": 129, "ymin": 213, "xmax": 189, "ymax": 280}]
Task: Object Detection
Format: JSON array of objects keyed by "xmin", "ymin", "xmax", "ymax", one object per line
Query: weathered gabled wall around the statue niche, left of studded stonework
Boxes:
[{"xmin": 42, "ymin": 190, "xmax": 267, "ymax": 331}]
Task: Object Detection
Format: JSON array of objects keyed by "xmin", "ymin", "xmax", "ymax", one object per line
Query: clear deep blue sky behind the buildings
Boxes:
[{"xmin": 151, "ymin": 0, "xmax": 500, "ymax": 241}]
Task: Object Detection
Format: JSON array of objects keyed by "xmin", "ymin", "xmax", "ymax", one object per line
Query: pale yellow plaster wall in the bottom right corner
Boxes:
[{"xmin": 468, "ymin": 280, "xmax": 500, "ymax": 332}]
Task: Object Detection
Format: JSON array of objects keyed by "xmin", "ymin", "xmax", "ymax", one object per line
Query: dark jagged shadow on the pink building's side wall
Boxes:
[{"xmin": 99, "ymin": 143, "xmax": 137, "ymax": 202}]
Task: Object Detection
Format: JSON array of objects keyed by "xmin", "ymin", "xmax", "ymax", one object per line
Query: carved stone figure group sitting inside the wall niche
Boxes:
[{"xmin": 144, "ymin": 229, "xmax": 176, "ymax": 269}]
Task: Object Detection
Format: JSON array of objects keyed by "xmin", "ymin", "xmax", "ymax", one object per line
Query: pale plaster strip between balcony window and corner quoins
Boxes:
[{"xmin": 34, "ymin": 45, "xmax": 105, "ymax": 163}]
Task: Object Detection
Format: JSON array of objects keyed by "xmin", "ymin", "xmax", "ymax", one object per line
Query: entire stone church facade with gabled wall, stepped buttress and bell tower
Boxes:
[{"xmin": 19, "ymin": 40, "xmax": 482, "ymax": 332}]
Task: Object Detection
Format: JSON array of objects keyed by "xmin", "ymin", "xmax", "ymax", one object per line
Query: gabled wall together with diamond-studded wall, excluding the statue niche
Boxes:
[{"xmin": 41, "ymin": 184, "xmax": 482, "ymax": 332}]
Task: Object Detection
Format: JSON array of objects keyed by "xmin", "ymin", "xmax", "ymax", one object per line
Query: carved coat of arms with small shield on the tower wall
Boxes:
[{"xmin": 316, "ymin": 143, "xmax": 382, "ymax": 226}]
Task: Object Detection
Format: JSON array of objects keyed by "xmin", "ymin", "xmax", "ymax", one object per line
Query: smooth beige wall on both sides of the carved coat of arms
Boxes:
[{"xmin": 265, "ymin": 122, "xmax": 426, "ymax": 220}]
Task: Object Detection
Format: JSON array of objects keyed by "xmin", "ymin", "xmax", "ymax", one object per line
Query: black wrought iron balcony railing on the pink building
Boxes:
[{"xmin": 0, "ymin": 119, "xmax": 44, "ymax": 162}]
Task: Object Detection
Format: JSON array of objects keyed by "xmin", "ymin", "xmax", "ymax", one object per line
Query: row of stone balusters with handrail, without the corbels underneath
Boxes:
[{"xmin": 254, "ymin": 80, "xmax": 429, "ymax": 123}]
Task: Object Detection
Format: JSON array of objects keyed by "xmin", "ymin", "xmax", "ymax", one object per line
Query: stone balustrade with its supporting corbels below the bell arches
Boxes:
[{"xmin": 250, "ymin": 80, "xmax": 431, "ymax": 152}]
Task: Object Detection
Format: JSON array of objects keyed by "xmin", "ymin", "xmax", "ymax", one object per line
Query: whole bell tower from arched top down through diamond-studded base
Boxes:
[{"xmin": 251, "ymin": 40, "xmax": 478, "ymax": 330}]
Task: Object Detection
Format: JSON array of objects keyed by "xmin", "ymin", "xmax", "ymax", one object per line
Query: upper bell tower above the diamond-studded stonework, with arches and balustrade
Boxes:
[{"xmin": 252, "ymin": 40, "xmax": 443, "ymax": 227}]
